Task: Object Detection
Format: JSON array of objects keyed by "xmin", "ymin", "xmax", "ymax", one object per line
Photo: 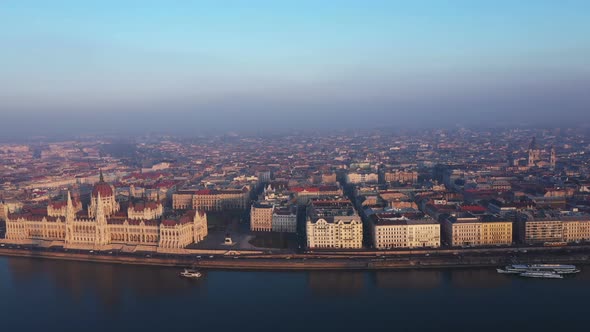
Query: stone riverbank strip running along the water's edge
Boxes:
[{"xmin": 0, "ymin": 248, "xmax": 590, "ymax": 271}]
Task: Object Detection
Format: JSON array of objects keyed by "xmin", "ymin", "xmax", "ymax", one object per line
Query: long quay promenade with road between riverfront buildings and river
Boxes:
[{"xmin": 0, "ymin": 246, "xmax": 590, "ymax": 270}]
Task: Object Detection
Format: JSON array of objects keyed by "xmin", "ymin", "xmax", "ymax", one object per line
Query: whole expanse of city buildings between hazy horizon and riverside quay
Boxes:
[{"xmin": 0, "ymin": 128, "xmax": 590, "ymax": 254}]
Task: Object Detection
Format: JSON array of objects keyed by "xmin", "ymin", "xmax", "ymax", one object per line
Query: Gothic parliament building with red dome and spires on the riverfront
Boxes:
[{"xmin": 6, "ymin": 174, "xmax": 207, "ymax": 250}]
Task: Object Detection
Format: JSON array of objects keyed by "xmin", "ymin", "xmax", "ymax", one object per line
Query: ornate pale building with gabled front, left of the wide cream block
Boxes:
[{"xmin": 305, "ymin": 199, "xmax": 363, "ymax": 249}]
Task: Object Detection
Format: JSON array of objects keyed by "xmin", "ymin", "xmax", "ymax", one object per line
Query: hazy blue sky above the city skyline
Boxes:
[{"xmin": 0, "ymin": 0, "xmax": 590, "ymax": 135}]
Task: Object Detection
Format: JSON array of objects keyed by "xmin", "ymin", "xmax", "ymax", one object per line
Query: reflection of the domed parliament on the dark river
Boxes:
[{"xmin": 7, "ymin": 258, "xmax": 206, "ymax": 308}]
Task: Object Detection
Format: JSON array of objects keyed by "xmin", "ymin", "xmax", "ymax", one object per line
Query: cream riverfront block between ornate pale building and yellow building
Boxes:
[{"xmin": 371, "ymin": 213, "xmax": 440, "ymax": 249}]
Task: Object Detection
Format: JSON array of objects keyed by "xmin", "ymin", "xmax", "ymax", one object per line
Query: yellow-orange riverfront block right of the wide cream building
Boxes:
[{"xmin": 442, "ymin": 213, "xmax": 512, "ymax": 247}]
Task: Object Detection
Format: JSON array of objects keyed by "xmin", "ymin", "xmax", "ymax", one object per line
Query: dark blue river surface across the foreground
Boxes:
[{"xmin": 0, "ymin": 257, "xmax": 590, "ymax": 332}]
